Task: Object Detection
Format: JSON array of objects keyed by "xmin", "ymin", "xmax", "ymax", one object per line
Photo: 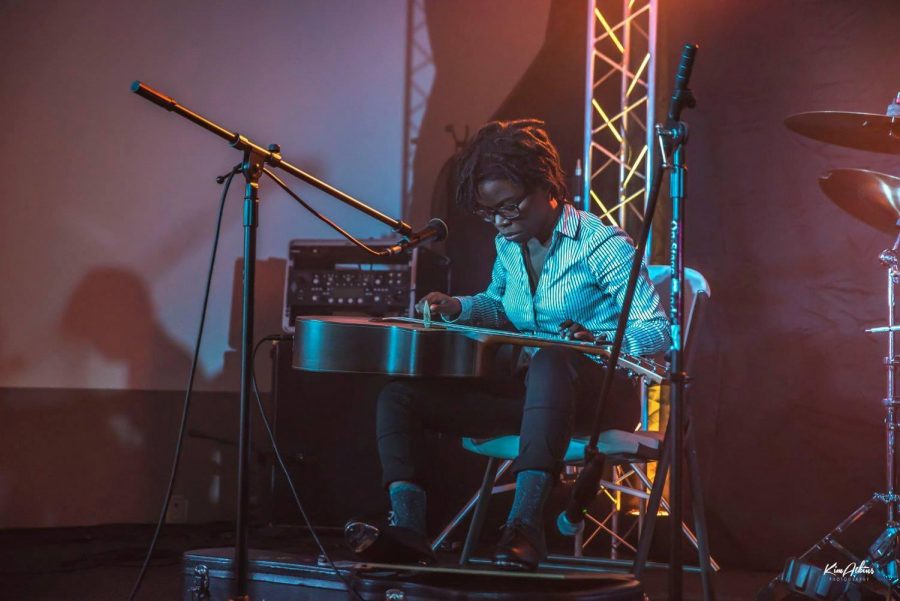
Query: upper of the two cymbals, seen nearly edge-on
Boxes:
[{"xmin": 784, "ymin": 111, "xmax": 900, "ymax": 154}]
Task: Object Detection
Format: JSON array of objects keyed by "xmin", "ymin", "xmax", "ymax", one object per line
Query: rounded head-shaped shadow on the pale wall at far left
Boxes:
[{"xmin": 61, "ymin": 267, "xmax": 202, "ymax": 390}]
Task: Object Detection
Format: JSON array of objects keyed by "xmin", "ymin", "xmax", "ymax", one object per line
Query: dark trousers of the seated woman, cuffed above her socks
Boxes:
[{"xmin": 376, "ymin": 347, "xmax": 640, "ymax": 486}]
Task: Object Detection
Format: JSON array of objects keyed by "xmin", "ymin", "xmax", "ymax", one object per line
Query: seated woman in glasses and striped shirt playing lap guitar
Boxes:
[{"xmin": 377, "ymin": 120, "xmax": 669, "ymax": 570}]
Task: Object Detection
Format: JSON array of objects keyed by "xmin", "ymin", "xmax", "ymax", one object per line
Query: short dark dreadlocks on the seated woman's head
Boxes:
[{"xmin": 456, "ymin": 119, "xmax": 568, "ymax": 211}]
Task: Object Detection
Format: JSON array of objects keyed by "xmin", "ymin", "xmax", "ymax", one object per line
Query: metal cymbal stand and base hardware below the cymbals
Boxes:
[{"xmin": 758, "ymin": 227, "xmax": 900, "ymax": 601}]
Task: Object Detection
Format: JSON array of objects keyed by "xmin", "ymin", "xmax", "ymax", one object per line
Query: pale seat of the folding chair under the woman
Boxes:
[{"xmin": 462, "ymin": 430, "xmax": 663, "ymax": 463}]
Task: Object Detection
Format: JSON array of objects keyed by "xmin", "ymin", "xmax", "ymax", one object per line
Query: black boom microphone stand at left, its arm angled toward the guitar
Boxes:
[{"xmin": 131, "ymin": 81, "xmax": 416, "ymax": 601}]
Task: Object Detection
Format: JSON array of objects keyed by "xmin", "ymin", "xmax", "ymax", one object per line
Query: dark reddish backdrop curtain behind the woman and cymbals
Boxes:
[{"xmin": 420, "ymin": 0, "xmax": 900, "ymax": 569}]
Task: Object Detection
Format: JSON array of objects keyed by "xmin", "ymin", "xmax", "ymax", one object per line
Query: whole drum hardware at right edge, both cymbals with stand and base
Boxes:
[{"xmin": 757, "ymin": 94, "xmax": 900, "ymax": 601}]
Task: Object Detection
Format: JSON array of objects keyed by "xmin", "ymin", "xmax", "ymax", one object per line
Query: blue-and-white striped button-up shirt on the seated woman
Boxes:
[{"xmin": 453, "ymin": 204, "xmax": 669, "ymax": 355}]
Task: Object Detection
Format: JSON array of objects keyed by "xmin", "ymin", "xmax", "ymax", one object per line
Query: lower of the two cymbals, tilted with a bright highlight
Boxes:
[{"xmin": 819, "ymin": 169, "xmax": 900, "ymax": 235}]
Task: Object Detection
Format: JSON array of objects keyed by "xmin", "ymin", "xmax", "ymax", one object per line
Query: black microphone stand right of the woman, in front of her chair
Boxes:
[{"xmin": 566, "ymin": 44, "xmax": 712, "ymax": 601}]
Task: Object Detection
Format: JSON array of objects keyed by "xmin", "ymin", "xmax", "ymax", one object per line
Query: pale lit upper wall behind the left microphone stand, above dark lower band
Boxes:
[{"xmin": 0, "ymin": 0, "xmax": 405, "ymax": 390}]
